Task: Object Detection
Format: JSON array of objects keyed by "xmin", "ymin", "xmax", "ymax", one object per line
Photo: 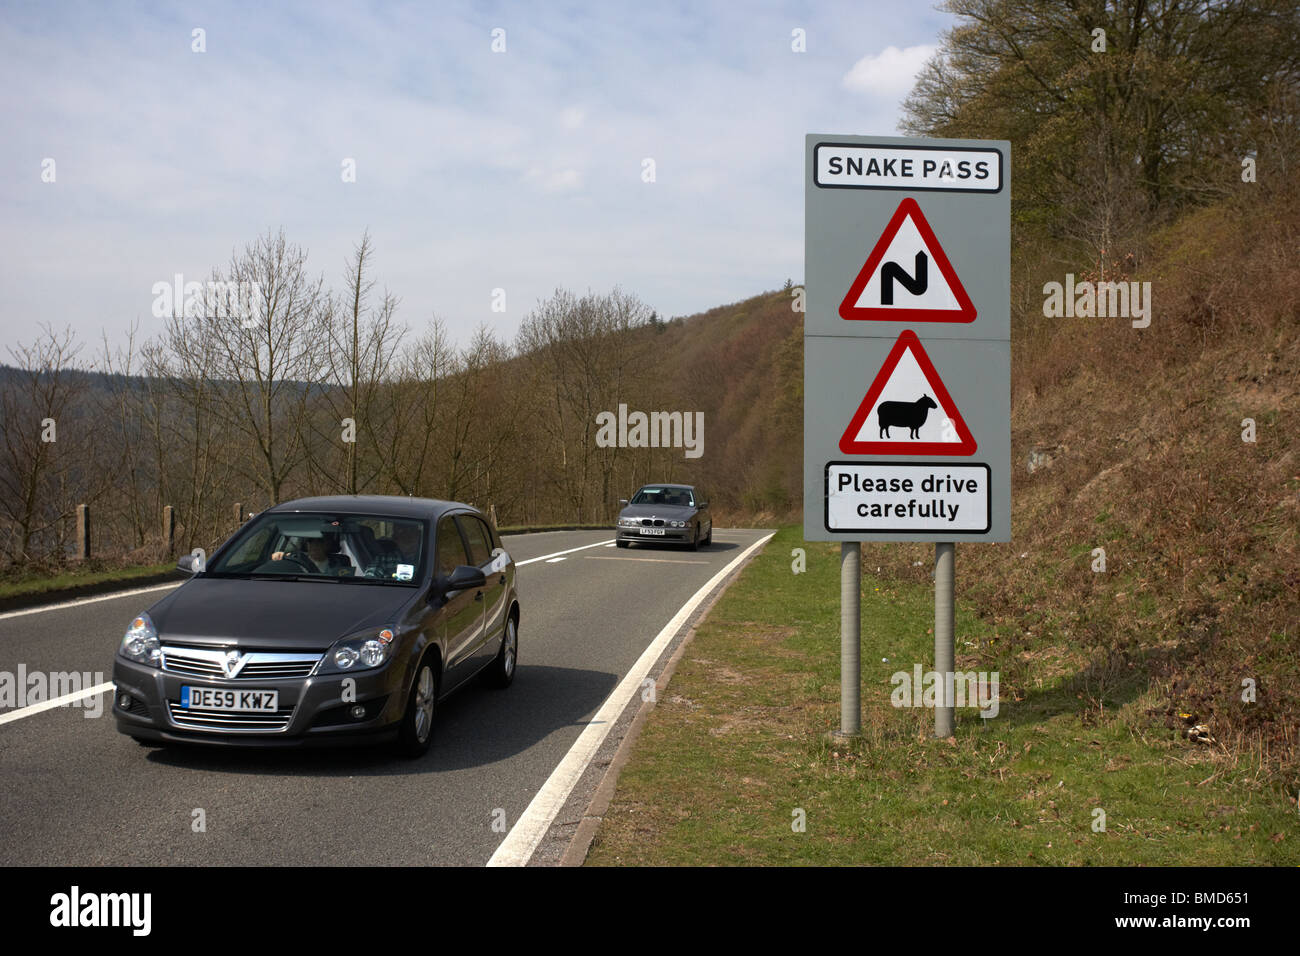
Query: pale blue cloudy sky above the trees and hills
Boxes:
[{"xmin": 0, "ymin": 0, "xmax": 949, "ymax": 362}]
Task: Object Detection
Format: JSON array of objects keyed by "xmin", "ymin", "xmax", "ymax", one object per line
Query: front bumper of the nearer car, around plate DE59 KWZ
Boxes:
[{"xmin": 113, "ymin": 656, "xmax": 406, "ymax": 747}]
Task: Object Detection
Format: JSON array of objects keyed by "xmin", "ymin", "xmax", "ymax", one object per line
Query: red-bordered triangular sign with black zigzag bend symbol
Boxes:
[{"xmin": 840, "ymin": 196, "xmax": 975, "ymax": 323}]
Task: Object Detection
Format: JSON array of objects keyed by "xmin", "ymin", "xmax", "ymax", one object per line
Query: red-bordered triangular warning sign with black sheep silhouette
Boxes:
[{"xmin": 840, "ymin": 330, "xmax": 976, "ymax": 455}]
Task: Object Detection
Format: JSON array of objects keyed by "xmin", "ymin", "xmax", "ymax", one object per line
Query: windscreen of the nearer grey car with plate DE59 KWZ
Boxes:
[{"xmin": 205, "ymin": 511, "xmax": 428, "ymax": 587}]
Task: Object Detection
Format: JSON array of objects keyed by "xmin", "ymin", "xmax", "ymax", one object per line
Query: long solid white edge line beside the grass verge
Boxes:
[{"xmin": 488, "ymin": 533, "xmax": 772, "ymax": 866}]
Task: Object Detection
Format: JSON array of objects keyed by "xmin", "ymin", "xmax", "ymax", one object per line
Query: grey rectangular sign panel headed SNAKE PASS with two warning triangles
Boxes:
[{"xmin": 803, "ymin": 135, "xmax": 1011, "ymax": 541}]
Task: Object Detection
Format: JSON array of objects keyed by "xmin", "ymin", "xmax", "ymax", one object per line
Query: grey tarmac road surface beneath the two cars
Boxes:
[{"xmin": 0, "ymin": 529, "xmax": 766, "ymax": 866}]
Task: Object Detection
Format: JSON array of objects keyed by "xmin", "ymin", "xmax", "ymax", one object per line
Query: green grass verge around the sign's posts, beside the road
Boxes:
[{"xmin": 588, "ymin": 528, "xmax": 1300, "ymax": 866}]
